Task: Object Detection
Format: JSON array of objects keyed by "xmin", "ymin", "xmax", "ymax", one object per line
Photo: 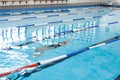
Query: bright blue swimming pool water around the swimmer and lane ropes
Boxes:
[{"xmin": 0, "ymin": 6, "xmax": 120, "ymax": 80}]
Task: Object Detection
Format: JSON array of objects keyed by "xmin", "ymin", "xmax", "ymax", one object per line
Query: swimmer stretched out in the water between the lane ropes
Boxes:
[{"xmin": 33, "ymin": 40, "xmax": 69, "ymax": 57}]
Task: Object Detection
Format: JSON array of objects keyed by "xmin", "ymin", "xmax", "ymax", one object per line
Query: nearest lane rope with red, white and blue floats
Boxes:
[{"xmin": 0, "ymin": 35, "xmax": 120, "ymax": 77}]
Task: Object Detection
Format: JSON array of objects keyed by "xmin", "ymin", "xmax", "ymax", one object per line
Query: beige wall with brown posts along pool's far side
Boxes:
[{"xmin": 0, "ymin": 0, "xmax": 112, "ymax": 7}]
